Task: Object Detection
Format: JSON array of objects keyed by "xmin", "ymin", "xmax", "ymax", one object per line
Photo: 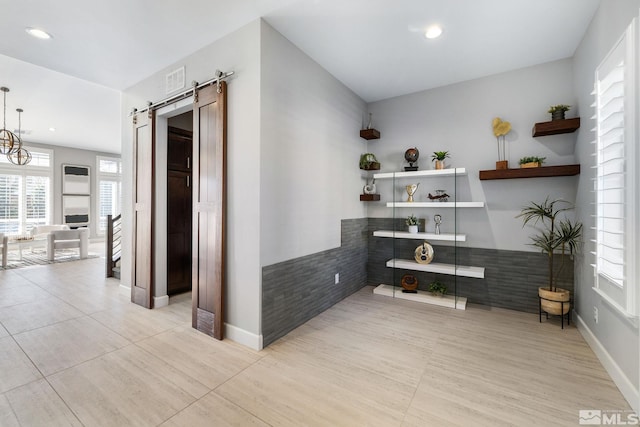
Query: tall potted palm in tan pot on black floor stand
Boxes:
[{"xmin": 516, "ymin": 197, "xmax": 582, "ymax": 315}]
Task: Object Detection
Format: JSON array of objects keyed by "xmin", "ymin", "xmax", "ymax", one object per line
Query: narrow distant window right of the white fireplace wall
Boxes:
[{"xmin": 97, "ymin": 157, "xmax": 122, "ymax": 235}]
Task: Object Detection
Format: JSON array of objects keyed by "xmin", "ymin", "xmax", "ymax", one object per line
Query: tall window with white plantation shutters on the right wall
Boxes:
[{"xmin": 594, "ymin": 19, "xmax": 640, "ymax": 317}]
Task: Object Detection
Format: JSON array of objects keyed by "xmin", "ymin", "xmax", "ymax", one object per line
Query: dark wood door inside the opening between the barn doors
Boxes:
[{"xmin": 167, "ymin": 127, "xmax": 193, "ymax": 295}]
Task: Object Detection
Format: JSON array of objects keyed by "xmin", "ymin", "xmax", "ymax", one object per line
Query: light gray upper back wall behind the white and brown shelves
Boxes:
[{"xmin": 368, "ymin": 59, "xmax": 577, "ymax": 251}]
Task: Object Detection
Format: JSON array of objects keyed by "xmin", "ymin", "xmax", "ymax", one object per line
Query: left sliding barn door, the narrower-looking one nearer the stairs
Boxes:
[{"xmin": 131, "ymin": 110, "xmax": 155, "ymax": 308}]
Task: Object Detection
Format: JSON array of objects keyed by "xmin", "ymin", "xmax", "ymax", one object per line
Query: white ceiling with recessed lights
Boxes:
[{"xmin": 0, "ymin": 0, "xmax": 600, "ymax": 153}]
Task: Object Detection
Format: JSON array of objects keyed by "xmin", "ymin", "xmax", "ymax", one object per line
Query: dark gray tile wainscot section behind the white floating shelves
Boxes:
[{"xmin": 367, "ymin": 218, "xmax": 573, "ymax": 313}]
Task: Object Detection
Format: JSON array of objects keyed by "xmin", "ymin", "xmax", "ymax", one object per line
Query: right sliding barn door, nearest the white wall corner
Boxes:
[{"xmin": 192, "ymin": 82, "xmax": 227, "ymax": 340}]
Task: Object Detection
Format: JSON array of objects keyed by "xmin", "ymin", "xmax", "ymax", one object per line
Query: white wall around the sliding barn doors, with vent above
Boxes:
[{"xmin": 122, "ymin": 21, "xmax": 261, "ymax": 347}]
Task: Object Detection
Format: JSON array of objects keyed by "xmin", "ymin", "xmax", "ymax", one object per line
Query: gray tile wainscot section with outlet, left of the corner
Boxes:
[{"xmin": 262, "ymin": 218, "xmax": 368, "ymax": 347}]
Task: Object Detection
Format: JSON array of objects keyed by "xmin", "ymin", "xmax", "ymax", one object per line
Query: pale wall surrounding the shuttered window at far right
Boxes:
[{"xmin": 574, "ymin": 0, "xmax": 640, "ymax": 411}]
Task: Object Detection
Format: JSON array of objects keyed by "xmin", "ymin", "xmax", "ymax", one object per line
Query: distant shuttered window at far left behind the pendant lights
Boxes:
[{"xmin": 0, "ymin": 148, "xmax": 53, "ymax": 234}]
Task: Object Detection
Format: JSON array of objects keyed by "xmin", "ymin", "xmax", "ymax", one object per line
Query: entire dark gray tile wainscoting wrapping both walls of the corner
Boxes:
[{"xmin": 262, "ymin": 218, "xmax": 573, "ymax": 347}]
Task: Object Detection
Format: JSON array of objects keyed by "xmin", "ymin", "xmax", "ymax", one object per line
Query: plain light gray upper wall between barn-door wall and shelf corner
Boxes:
[{"xmin": 259, "ymin": 22, "xmax": 366, "ymax": 266}]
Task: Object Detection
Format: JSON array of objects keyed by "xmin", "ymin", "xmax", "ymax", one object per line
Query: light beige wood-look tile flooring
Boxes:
[{"xmin": 0, "ymin": 249, "xmax": 629, "ymax": 427}]
